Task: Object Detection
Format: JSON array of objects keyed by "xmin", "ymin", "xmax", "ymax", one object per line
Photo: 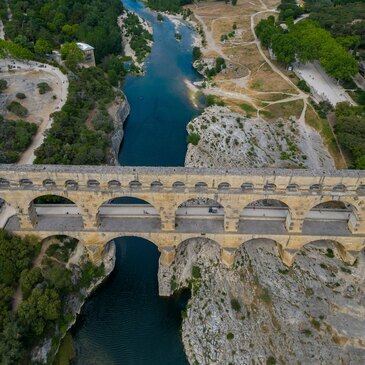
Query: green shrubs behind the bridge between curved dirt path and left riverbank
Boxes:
[{"xmin": 35, "ymin": 67, "xmax": 119, "ymax": 165}]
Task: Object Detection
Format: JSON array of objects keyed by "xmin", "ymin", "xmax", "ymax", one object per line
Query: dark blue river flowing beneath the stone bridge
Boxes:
[{"xmin": 73, "ymin": 0, "xmax": 200, "ymax": 365}]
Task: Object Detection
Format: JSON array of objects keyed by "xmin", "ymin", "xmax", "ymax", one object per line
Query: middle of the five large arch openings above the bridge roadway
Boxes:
[{"xmin": 175, "ymin": 197, "xmax": 224, "ymax": 233}]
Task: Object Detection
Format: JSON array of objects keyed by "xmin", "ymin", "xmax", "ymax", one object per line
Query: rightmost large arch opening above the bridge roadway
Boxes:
[{"xmin": 303, "ymin": 196, "xmax": 361, "ymax": 232}]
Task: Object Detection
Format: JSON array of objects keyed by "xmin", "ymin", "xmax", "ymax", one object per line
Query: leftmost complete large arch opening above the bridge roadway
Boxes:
[{"xmin": 28, "ymin": 194, "xmax": 83, "ymax": 231}]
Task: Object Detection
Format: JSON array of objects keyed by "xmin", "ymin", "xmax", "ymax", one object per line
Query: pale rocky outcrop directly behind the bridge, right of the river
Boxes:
[{"xmin": 185, "ymin": 106, "xmax": 333, "ymax": 169}]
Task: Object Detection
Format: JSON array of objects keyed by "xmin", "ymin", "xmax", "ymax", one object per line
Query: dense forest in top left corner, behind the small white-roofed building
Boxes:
[{"xmin": 4, "ymin": 0, "xmax": 123, "ymax": 62}]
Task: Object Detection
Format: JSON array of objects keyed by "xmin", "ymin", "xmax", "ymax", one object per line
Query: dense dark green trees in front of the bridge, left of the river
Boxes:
[{"xmin": 0, "ymin": 230, "xmax": 104, "ymax": 365}]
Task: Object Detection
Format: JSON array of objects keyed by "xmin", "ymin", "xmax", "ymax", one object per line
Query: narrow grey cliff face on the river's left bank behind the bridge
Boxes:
[{"xmin": 109, "ymin": 94, "xmax": 131, "ymax": 165}]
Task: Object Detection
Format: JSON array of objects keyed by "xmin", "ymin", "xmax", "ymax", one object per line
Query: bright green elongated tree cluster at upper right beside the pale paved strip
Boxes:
[{"xmin": 255, "ymin": 16, "xmax": 358, "ymax": 79}]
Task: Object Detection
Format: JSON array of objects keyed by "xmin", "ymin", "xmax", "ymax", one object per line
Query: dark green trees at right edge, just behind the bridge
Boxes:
[{"xmin": 334, "ymin": 103, "xmax": 365, "ymax": 170}]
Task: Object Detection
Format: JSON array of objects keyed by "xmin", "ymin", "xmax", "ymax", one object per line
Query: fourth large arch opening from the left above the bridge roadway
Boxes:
[{"xmin": 239, "ymin": 199, "xmax": 291, "ymax": 233}]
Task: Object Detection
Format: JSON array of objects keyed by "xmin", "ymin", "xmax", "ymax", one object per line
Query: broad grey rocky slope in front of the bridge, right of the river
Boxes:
[{"xmin": 159, "ymin": 238, "xmax": 365, "ymax": 365}]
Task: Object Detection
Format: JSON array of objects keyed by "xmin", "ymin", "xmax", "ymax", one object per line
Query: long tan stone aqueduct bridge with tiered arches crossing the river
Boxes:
[{"xmin": 0, "ymin": 165, "xmax": 365, "ymax": 266}]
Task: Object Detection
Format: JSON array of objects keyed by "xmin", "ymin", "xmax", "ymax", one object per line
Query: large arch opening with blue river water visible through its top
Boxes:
[{"xmin": 97, "ymin": 196, "xmax": 161, "ymax": 232}]
